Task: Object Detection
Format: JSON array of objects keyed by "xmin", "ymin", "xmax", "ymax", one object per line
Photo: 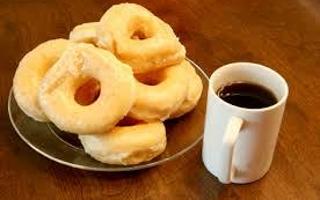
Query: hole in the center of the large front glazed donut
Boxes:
[{"xmin": 74, "ymin": 78, "xmax": 100, "ymax": 106}]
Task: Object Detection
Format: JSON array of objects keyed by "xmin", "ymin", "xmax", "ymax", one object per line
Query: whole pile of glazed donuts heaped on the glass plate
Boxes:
[{"xmin": 13, "ymin": 3, "xmax": 202, "ymax": 165}]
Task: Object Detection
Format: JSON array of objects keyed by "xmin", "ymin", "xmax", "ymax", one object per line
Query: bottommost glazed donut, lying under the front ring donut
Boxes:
[{"xmin": 79, "ymin": 121, "xmax": 167, "ymax": 165}]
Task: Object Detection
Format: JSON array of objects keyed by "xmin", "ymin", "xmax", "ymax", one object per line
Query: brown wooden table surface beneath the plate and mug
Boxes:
[{"xmin": 0, "ymin": 0, "xmax": 320, "ymax": 200}]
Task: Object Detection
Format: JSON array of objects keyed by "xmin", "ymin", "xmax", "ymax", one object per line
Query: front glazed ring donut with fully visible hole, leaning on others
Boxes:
[{"xmin": 39, "ymin": 43, "xmax": 135, "ymax": 134}]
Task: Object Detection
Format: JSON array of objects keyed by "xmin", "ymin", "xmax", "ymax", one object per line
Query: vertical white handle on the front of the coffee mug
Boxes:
[{"xmin": 219, "ymin": 116, "xmax": 243, "ymax": 183}]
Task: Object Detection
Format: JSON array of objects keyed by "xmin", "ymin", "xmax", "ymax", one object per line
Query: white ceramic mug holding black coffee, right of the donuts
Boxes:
[{"xmin": 202, "ymin": 62, "xmax": 289, "ymax": 183}]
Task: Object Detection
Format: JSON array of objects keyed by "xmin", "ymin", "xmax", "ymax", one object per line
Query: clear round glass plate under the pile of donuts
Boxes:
[{"xmin": 8, "ymin": 59, "xmax": 208, "ymax": 172}]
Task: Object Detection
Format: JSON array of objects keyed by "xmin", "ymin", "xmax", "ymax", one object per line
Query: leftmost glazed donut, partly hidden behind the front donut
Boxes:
[{"xmin": 13, "ymin": 39, "xmax": 69, "ymax": 122}]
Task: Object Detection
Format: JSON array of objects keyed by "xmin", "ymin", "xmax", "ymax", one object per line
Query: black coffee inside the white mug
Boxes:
[{"xmin": 217, "ymin": 82, "xmax": 277, "ymax": 108}]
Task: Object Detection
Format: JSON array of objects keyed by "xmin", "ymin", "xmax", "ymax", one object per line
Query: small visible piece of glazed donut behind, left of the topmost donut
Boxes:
[{"xmin": 69, "ymin": 22, "xmax": 98, "ymax": 45}]
